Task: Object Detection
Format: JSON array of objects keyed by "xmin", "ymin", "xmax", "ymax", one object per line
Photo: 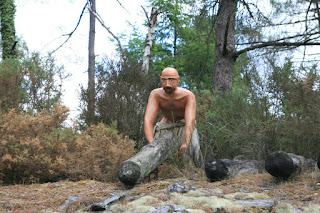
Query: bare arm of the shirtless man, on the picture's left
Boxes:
[{"xmin": 144, "ymin": 90, "xmax": 159, "ymax": 143}]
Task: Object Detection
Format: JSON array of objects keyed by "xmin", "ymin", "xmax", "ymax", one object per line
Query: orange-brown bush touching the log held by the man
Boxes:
[{"xmin": 68, "ymin": 123, "xmax": 135, "ymax": 181}]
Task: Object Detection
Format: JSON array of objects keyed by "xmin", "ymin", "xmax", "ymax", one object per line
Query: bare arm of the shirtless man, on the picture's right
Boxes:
[{"xmin": 180, "ymin": 92, "xmax": 196, "ymax": 152}]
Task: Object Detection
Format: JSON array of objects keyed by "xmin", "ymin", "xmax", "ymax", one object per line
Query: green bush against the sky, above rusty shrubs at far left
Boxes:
[{"xmin": 0, "ymin": 52, "xmax": 66, "ymax": 114}]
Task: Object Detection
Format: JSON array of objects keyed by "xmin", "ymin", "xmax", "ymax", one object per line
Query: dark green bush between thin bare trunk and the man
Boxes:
[{"xmin": 81, "ymin": 59, "xmax": 159, "ymax": 147}]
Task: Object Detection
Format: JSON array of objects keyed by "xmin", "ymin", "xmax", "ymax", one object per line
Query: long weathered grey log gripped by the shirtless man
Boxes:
[{"xmin": 118, "ymin": 132, "xmax": 180, "ymax": 187}]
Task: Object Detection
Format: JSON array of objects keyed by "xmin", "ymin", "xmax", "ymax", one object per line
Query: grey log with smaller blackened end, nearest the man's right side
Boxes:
[{"xmin": 205, "ymin": 159, "xmax": 265, "ymax": 181}]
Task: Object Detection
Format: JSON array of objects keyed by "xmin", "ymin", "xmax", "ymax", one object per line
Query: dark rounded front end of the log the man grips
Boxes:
[{"xmin": 118, "ymin": 161, "xmax": 140, "ymax": 188}]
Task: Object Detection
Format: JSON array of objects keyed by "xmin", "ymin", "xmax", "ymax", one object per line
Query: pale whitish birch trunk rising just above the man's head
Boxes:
[{"xmin": 142, "ymin": 7, "xmax": 159, "ymax": 75}]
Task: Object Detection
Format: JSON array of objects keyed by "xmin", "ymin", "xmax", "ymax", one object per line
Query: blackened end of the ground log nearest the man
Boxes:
[{"xmin": 204, "ymin": 160, "xmax": 228, "ymax": 182}]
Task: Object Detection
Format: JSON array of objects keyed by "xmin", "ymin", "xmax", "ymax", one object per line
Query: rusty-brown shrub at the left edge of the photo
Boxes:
[{"xmin": 0, "ymin": 103, "xmax": 74, "ymax": 183}]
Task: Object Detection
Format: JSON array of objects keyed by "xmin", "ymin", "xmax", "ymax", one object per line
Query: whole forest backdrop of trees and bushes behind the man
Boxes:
[{"xmin": 0, "ymin": 0, "xmax": 320, "ymax": 183}]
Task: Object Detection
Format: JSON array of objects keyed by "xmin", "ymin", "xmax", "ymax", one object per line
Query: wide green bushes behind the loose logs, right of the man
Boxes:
[{"xmin": 195, "ymin": 55, "xmax": 320, "ymax": 160}]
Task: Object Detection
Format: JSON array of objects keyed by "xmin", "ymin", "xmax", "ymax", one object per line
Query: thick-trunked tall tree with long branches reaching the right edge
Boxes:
[{"xmin": 212, "ymin": 0, "xmax": 320, "ymax": 93}]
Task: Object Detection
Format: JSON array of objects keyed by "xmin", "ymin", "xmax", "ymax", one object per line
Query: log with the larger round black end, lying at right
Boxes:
[{"xmin": 265, "ymin": 152, "xmax": 316, "ymax": 179}]
